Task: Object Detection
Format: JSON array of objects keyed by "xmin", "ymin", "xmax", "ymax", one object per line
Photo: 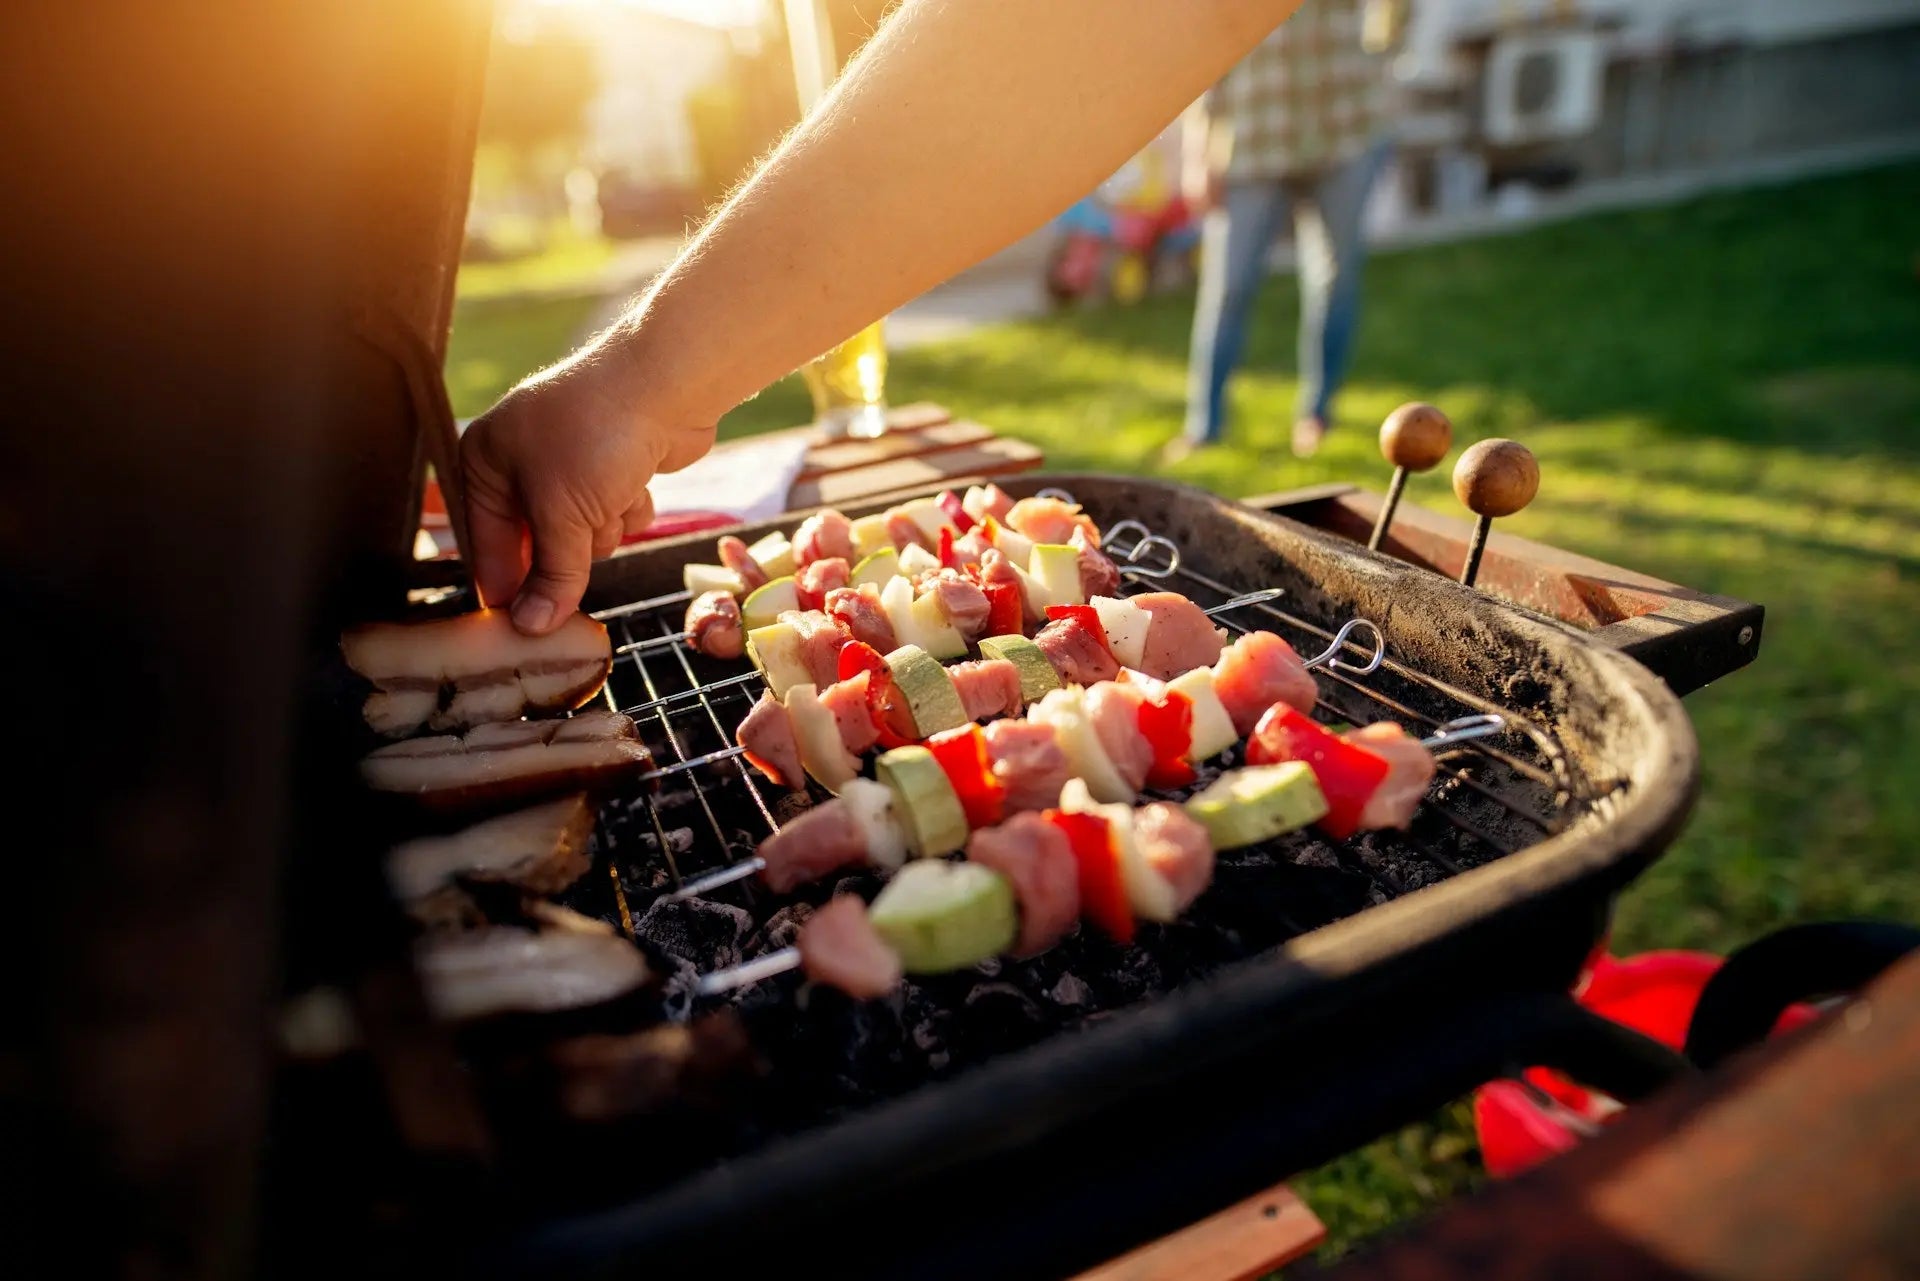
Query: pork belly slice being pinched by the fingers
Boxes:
[{"xmin": 340, "ymin": 609, "xmax": 612, "ymax": 737}]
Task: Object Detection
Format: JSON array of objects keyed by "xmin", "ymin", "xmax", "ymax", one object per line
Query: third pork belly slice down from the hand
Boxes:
[{"xmin": 386, "ymin": 791, "xmax": 593, "ymax": 926}]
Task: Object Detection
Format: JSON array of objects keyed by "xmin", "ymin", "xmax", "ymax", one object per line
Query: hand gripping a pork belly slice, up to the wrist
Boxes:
[{"xmin": 461, "ymin": 344, "xmax": 714, "ymax": 636}]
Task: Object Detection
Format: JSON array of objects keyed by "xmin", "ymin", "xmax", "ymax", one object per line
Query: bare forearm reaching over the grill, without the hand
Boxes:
[{"xmin": 605, "ymin": 0, "xmax": 1300, "ymax": 422}]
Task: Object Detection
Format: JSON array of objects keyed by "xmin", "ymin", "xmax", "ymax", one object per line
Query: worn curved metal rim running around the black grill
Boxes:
[{"xmin": 493, "ymin": 472, "xmax": 1699, "ymax": 1271}]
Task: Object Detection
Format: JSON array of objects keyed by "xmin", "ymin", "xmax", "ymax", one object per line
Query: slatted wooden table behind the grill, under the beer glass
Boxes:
[{"xmin": 415, "ymin": 401, "xmax": 1046, "ymax": 561}]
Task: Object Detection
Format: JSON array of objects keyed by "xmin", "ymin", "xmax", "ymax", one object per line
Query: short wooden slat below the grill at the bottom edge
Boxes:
[{"xmin": 1075, "ymin": 1183, "xmax": 1327, "ymax": 1281}]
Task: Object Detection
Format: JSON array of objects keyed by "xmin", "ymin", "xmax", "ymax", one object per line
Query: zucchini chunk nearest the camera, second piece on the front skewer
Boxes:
[{"xmin": 868, "ymin": 860, "xmax": 1020, "ymax": 974}]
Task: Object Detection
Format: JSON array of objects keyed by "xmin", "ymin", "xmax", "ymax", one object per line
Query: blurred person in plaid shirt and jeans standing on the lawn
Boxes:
[{"xmin": 1162, "ymin": 0, "xmax": 1390, "ymax": 461}]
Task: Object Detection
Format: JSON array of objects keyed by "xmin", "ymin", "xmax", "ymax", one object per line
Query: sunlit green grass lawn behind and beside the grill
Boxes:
[{"xmin": 451, "ymin": 165, "xmax": 1920, "ymax": 1248}]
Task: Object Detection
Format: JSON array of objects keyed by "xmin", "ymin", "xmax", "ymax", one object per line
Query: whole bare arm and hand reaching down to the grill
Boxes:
[{"xmin": 463, "ymin": 0, "xmax": 1300, "ymax": 632}]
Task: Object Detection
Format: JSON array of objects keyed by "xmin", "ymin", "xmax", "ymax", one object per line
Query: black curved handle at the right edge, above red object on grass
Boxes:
[{"xmin": 1686, "ymin": 920, "xmax": 1920, "ymax": 1070}]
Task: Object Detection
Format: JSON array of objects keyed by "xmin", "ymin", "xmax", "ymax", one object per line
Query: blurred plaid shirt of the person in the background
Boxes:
[{"xmin": 1204, "ymin": 0, "xmax": 1386, "ymax": 182}]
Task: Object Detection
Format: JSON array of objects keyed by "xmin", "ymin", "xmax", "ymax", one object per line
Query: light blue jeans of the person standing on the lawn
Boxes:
[{"xmin": 1187, "ymin": 142, "xmax": 1390, "ymax": 444}]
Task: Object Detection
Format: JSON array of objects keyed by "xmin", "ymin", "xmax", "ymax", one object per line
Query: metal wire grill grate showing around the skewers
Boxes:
[{"xmin": 568, "ymin": 522, "xmax": 1588, "ymax": 971}]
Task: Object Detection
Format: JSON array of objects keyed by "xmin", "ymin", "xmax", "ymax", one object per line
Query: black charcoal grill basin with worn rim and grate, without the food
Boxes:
[{"xmin": 337, "ymin": 474, "xmax": 1697, "ymax": 1277}]
